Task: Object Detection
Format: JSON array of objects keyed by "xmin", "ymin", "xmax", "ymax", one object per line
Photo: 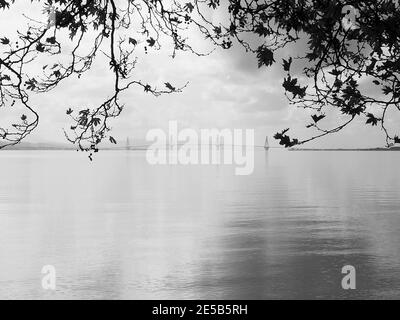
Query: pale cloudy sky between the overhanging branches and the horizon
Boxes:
[{"xmin": 0, "ymin": 1, "xmax": 392, "ymax": 148}]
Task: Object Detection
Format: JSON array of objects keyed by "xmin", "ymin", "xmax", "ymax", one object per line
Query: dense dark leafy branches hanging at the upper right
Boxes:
[{"xmin": 216, "ymin": 0, "xmax": 400, "ymax": 147}]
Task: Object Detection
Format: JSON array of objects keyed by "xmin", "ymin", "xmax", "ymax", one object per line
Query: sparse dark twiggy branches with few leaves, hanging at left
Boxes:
[{"xmin": 0, "ymin": 0, "xmax": 194, "ymax": 152}]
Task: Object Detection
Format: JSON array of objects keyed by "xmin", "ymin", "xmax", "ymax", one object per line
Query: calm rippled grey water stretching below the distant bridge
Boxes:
[{"xmin": 0, "ymin": 150, "xmax": 400, "ymax": 299}]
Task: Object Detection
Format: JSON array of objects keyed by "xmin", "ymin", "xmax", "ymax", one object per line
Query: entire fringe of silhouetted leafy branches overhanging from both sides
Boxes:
[{"xmin": 0, "ymin": 0, "xmax": 400, "ymax": 151}]
